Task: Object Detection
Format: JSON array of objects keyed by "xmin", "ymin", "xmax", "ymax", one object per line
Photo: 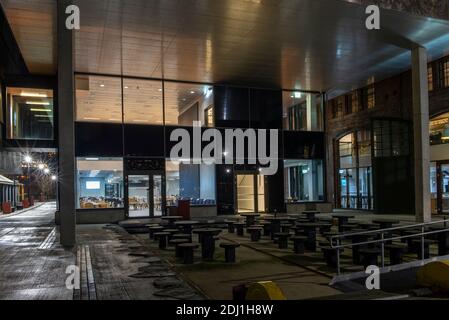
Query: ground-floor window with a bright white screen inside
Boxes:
[{"xmin": 76, "ymin": 158, "xmax": 124, "ymax": 209}]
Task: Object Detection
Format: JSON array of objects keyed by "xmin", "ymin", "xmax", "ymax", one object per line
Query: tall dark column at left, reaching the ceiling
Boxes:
[{"xmin": 58, "ymin": 0, "xmax": 76, "ymax": 247}]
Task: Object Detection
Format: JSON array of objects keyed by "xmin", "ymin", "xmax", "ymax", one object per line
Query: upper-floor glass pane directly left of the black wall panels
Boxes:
[{"xmin": 165, "ymin": 82, "xmax": 214, "ymax": 127}]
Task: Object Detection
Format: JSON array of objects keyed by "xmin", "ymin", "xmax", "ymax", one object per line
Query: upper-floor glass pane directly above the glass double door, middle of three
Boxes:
[{"xmin": 123, "ymin": 78, "xmax": 164, "ymax": 125}]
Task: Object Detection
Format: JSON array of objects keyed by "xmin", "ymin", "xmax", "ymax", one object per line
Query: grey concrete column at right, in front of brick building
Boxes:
[{"xmin": 412, "ymin": 47, "xmax": 432, "ymax": 222}]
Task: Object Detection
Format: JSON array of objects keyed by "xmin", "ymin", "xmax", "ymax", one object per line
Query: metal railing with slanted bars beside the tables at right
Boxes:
[{"xmin": 329, "ymin": 217, "xmax": 449, "ymax": 275}]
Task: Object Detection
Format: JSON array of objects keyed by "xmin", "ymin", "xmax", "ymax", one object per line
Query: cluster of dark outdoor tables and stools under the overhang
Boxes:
[{"xmin": 141, "ymin": 211, "xmax": 449, "ymax": 275}]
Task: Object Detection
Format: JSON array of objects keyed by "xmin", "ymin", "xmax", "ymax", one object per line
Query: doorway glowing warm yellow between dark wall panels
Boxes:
[{"xmin": 236, "ymin": 173, "xmax": 266, "ymax": 213}]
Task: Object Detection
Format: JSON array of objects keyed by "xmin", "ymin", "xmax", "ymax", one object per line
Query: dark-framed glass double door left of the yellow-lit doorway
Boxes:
[{"xmin": 125, "ymin": 171, "xmax": 165, "ymax": 218}]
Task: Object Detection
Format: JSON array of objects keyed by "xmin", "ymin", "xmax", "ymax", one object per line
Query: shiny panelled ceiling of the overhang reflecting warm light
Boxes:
[{"xmin": 0, "ymin": 0, "xmax": 449, "ymax": 96}]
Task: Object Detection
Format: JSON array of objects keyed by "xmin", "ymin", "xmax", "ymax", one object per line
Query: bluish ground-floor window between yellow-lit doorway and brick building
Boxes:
[{"xmin": 284, "ymin": 160, "xmax": 324, "ymax": 203}]
